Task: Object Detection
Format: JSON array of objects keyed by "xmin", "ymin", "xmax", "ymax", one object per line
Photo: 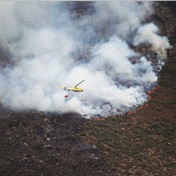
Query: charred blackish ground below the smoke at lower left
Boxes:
[{"xmin": 0, "ymin": 111, "xmax": 102, "ymax": 176}]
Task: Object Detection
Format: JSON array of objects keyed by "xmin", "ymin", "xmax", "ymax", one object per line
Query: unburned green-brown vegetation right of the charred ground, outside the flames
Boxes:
[{"xmin": 81, "ymin": 59, "xmax": 176, "ymax": 176}]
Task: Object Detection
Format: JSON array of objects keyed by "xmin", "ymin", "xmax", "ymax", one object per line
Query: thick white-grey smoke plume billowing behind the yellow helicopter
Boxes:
[{"xmin": 0, "ymin": 2, "xmax": 170, "ymax": 116}]
